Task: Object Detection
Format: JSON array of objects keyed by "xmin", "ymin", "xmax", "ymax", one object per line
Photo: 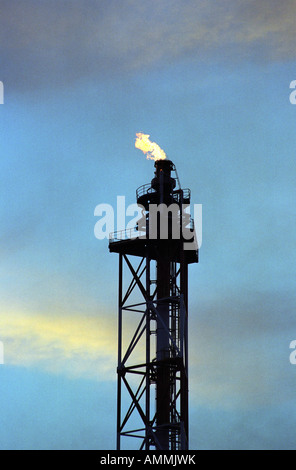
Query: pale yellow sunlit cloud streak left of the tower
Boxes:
[{"xmin": 0, "ymin": 312, "xmax": 117, "ymax": 380}]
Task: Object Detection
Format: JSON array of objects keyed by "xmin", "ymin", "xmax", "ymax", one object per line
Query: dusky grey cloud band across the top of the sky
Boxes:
[{"xmin": 0, "ymin": 0, "xmax": 296, "ymax": 90}]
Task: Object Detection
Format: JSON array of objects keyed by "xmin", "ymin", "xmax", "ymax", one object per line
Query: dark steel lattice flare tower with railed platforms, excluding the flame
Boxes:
[{"xmin": 109, "ymin": 160, "xmax": 198, "ymax": 450}]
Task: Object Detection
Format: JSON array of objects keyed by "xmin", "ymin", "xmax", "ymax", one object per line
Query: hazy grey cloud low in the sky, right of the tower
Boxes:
[{"xmin": 189, "ymin": 290, "xmax": 295, "ymax": 410}]
